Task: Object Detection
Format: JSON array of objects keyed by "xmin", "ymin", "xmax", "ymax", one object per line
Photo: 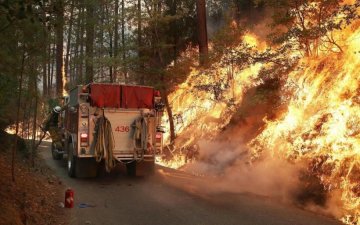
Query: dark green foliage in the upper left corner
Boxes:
[{"xmin": 0, "ymin": 0, "xmax": 43, "ymax": 130}]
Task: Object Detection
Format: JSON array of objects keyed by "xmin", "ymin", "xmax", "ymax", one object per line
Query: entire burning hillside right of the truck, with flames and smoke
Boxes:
[{"xmin": 160, "ymin": 1, "xmax": 360, "ymax": 225}]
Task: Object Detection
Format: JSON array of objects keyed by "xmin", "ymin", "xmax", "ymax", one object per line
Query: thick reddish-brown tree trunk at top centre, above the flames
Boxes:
[{"xmin": 196, "ymin": 0, "xmax": 209, "ymax": 65}]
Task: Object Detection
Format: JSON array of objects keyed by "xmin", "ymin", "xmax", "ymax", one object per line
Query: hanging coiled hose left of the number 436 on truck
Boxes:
[{"xmin": 94, "ymin": 116, "xmax": 116, "ymax": 172}]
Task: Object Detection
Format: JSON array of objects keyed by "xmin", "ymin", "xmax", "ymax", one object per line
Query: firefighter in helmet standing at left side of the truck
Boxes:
[{"xmin": 43, "ymin": 106, "xmax": 62, "ymax": 150}]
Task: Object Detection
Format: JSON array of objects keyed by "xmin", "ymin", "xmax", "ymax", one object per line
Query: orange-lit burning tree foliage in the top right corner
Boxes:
[{"xmin": 268, "ymin": 0, "xmax": 360, "ymax": 55}]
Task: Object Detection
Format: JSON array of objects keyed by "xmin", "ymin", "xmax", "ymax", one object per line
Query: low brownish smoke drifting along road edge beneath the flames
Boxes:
[{"xmin": 160, "ymin": 139, "xmax": 343, "ymax": 221}]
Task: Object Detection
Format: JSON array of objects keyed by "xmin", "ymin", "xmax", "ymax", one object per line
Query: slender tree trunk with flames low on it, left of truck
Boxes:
[{"xmin": 55, "ymin": 0, "xmax": 64, "ymax": 97}]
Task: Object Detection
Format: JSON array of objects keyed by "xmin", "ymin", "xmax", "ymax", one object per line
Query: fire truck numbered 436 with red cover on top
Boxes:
[{"xmin": 53, "ymin": 83, "xmax": 164, "ymax": 177}]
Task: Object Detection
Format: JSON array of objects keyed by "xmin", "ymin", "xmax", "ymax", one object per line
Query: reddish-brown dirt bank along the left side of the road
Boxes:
[{"xmin": 0, "ymin": 136, "xmax": 69, "ymax": 225}]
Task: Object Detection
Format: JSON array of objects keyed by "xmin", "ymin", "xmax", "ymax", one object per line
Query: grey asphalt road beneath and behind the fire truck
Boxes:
[{"xmin": 40, "ymin": 143, "xmax": 341, "ymax": 225}]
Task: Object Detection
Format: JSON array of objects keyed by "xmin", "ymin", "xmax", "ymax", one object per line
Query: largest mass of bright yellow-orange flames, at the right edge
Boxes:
[{"xmin": 251, "ymin": 22, "xmax": 360, "ymax": 225}]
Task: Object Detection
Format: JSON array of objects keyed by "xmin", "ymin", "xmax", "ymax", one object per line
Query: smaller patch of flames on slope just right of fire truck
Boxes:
[{"xmin": 163, "ymin": 33, "xmax": 265, "ymax": 155}]
